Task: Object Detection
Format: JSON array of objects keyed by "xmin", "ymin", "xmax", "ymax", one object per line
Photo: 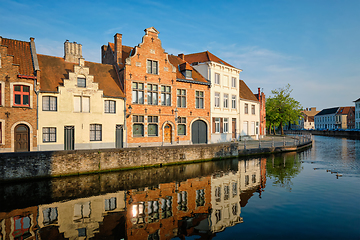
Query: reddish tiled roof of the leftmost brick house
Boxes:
[{"xmin": 1, "ymin": 38, "xmax": 35, "ymax": 76}]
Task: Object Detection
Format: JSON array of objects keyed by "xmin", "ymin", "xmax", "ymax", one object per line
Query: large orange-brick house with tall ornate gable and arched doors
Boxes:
[{"xmin": 102, "ymin": 27, "xmax": 211, "ymax": 147}]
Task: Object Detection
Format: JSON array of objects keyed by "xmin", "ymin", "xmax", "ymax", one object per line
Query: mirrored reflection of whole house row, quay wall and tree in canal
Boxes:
[{"xmin": 0, "ymin": 155, "xmax": 306, "ymax": 240}]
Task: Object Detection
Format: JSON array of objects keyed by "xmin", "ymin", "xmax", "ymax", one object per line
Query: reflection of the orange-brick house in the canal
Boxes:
[{"xmin": 126, "ymin": 177, "xmax": 211, "ymax": 239}]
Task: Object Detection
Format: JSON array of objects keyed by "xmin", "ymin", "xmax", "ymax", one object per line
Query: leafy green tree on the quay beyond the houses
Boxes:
[{"xmin": 266, "ymin": 84, "xmax": 302, "ymax": 135}]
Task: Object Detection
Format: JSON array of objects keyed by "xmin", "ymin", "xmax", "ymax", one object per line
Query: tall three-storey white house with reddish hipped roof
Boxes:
[{"xmin": 185, "ymin": 51, "xmax": 242, "ymax": 143}]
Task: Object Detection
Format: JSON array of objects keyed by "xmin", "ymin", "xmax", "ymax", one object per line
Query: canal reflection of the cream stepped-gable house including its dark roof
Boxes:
[{"xmin": 38, "ymin": 191, "xmax": 125, "ymax": 239}]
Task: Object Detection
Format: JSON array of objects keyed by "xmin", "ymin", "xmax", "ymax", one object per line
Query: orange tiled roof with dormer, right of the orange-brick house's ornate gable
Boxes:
[{"xmin": 168, "ymin": 55, "xmax": 210, "ymax": 85}]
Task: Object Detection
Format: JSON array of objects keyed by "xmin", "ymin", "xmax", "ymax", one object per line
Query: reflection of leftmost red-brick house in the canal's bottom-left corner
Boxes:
[{"xmin": 0, "ymin": 206, "xmax": 37, "ymax": 240}]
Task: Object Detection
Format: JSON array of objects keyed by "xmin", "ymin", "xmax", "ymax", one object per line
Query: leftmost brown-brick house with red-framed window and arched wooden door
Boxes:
[{"xmin": 0, "ymin": 37, "xmax": 39, "ymax": 152}]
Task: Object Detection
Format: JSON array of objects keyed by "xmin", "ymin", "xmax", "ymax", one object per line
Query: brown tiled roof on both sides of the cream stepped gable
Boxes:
[{"xmin": 37, "ymin": 54, "xmax": 125, "ymax": 97}]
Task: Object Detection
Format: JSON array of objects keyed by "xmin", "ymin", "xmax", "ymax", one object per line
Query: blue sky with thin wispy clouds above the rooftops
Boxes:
[{"xmin": 0, "ymin": 0, "xmax": 360, "ymax": 110}]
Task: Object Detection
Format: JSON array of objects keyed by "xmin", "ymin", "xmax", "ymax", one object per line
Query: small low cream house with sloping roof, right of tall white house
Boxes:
[{"xmin": 239, "ymin": 80, "xmax": 260, "ymax": 139}]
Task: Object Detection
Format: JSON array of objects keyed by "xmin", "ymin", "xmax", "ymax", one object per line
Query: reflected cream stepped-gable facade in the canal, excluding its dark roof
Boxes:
[{"xmin": 38, "ymin": 191, "xmax": 125, "ymax": 239}]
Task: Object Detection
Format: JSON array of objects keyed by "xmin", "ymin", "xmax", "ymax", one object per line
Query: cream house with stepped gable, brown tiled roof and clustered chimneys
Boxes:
[{"xmin": 38, "ymin": 41, "xmax": 125, "ymax": 151}]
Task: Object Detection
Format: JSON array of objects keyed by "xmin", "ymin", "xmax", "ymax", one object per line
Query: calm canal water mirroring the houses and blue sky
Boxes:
[{"xmin": 0, "ymin": 136, "xmax": 360, "ymax": 240}]
